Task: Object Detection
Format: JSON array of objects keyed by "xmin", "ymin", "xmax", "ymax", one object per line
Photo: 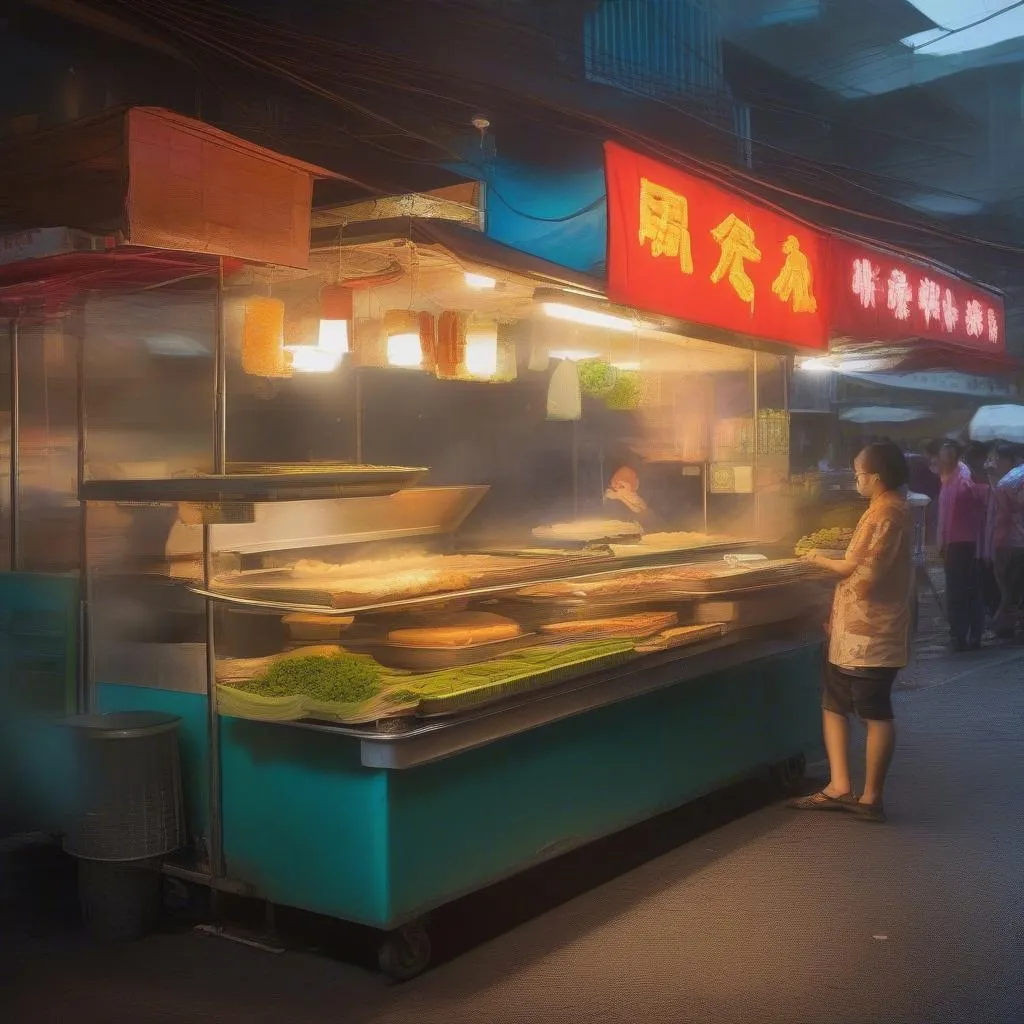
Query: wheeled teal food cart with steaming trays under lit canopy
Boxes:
[{"xmin": 82, "ymin": 220, "xmax": 828, "ymax": 977}]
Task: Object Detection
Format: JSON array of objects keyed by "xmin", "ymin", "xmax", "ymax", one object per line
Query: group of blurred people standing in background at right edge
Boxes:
[{"xmin": 929, "ymin": 439, "xmax": 1024, "ymax": 651}]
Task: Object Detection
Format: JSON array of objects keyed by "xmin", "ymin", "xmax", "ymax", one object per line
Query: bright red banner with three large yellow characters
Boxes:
[{"xmin": 604, "ymin": 142, "xmax": 829, "ymax": 349}]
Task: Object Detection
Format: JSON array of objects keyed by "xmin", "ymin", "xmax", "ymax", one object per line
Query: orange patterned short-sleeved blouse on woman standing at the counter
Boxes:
[{"xmin": 828, "ymin": 490, "xmax": 913, "ymax": 669}]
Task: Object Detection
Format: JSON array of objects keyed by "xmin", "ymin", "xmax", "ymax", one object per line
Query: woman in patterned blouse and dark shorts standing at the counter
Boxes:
[{"xmin": 792, "ymin": 441, "xmax": 913, "ymax": 821}]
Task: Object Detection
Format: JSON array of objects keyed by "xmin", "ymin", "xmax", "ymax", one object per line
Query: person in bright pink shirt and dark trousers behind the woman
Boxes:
[{"xmin": 936, "ymin": 440, "xmax": 986, "ymax": 651}]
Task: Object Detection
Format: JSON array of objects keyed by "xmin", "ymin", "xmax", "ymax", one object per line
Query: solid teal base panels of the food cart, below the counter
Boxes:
[{"xmin": 221, "ymin": 645, "xmax": 820, "ymax": 930}]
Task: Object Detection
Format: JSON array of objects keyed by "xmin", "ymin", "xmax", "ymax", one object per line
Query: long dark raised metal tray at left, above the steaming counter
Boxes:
[{"xmin": 79, "ymin": 463, "xmax": 429, "ymax": 504}]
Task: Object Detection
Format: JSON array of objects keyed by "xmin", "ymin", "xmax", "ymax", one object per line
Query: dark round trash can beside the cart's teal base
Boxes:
[{"xmin": 65, "ymin": 712, "xmax": 185, "ymax": 941}]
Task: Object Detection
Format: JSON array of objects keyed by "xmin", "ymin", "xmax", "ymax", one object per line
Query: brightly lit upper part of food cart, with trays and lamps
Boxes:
[{"xmin": 82, "ymin": 228, "xmax": 820, "ymax": 729}]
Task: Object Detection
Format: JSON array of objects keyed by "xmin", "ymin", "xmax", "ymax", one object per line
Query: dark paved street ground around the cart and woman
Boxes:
[{"xmin": 0, "ymin": 589, "xmax": 1024, "ymax": 1024}]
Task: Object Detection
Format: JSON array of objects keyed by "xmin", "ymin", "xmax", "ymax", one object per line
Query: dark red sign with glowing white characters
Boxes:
[{"xmin": 831, "ymin": 239, "xmax": 1007, "ymax": 352}]
